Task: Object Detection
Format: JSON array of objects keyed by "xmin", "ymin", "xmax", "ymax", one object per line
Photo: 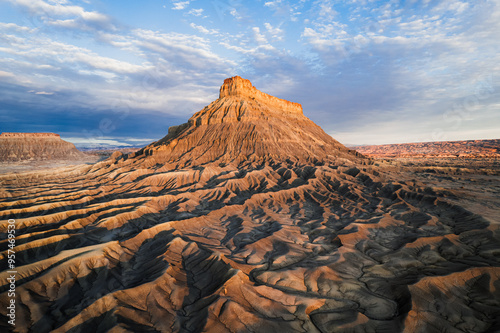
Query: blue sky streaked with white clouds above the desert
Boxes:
[{"xmin": 0, "ymin": 0, "xmax": 500, "ymax": 147}]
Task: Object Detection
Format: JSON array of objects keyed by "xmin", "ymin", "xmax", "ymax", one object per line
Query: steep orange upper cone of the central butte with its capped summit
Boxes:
[{"xmin": 142, "ymin": 76, "xmax": 364, "ymax": 166}]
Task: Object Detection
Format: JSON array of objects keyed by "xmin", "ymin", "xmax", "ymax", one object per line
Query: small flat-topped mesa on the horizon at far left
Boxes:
[{"xmin": 0, "ymin": 133, "xmax": 86, "ymax": 162}]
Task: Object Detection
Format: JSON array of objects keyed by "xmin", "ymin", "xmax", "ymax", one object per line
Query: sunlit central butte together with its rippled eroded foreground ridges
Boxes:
[{"xmin": 0, "ymin": 77, "xmax": 500, "ymax": 333}]
